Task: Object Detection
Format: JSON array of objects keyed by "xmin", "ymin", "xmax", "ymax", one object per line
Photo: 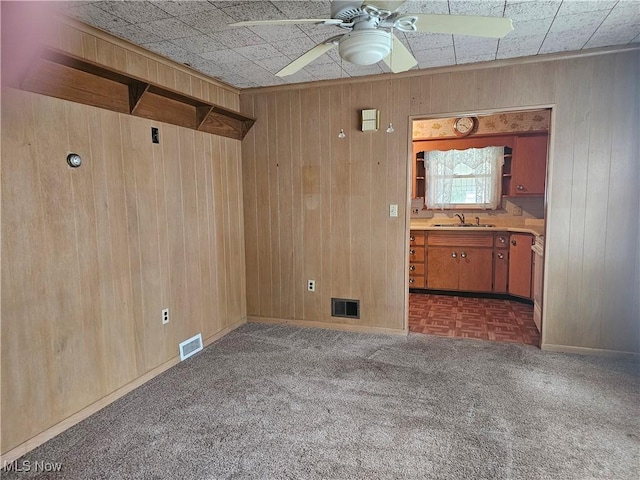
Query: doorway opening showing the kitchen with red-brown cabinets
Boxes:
[{"xmin": 406, "ymin": 106, "xmax": 552, "ymax": 347}]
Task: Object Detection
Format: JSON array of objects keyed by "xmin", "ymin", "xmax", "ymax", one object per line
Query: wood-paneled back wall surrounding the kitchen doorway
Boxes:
[{"xmin": 240, "ymin": 50, "xmax": 640, "ymax": 353}]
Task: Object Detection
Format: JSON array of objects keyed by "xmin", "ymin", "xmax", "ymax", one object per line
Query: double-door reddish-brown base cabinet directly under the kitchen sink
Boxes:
[{"xmin": 426, "ymin": 232, "xmax": 493, "ymax": 292}]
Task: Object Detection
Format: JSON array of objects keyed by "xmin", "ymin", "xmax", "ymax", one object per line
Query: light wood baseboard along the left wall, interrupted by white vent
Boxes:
[{"xmin": 0, "ymin": 317, "xmax": 247, "ymax": 465}]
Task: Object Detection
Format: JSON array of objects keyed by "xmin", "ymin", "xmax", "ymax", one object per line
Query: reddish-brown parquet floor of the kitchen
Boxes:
[{"xmin": 409, "ymin": 293, "xmax": 540, "ymax": 346}]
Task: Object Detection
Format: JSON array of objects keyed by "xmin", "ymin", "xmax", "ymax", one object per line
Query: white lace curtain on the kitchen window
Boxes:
[{"xmin": 425, "ymin": 147, "xmax": 504, "ymax": 210}]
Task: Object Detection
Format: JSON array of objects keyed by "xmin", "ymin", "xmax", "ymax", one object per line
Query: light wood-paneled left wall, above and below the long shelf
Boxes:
[{"xmin": 1, "ymin": 19, "xmax": 246, "ymax": 454}]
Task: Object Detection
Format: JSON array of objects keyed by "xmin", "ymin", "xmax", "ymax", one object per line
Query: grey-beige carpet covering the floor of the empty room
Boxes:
[{"xmin": 2, "ymin": 324, "xmax": 640, "ymax": 480}]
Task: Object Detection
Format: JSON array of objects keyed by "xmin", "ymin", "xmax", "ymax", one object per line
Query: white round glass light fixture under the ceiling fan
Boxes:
[{"xmin": 338, "ymin": 30, "xmax": 391, "ymax": 65}]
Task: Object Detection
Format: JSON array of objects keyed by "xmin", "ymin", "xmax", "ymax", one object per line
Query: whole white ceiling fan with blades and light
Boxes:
[{"xmin": 231, "ymin": 0, "xmax": 513, "ymax": 77}]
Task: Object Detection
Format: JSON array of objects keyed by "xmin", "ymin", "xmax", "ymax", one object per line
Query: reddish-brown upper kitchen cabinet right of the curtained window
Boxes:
[{"xmin": 502, "ymin": 133, "xmax": 548, "ymax": 197}]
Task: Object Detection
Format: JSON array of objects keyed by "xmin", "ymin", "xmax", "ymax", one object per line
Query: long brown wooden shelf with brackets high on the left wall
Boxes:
[{"xmin": 20, "ymin": 49, "xmax": 255, "ymax": 140}]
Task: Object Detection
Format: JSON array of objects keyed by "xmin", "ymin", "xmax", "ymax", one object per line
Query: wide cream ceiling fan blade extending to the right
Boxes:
[{"xmin": 407, "ymin": 13, "xmax": 513, "ymax": 38}]
